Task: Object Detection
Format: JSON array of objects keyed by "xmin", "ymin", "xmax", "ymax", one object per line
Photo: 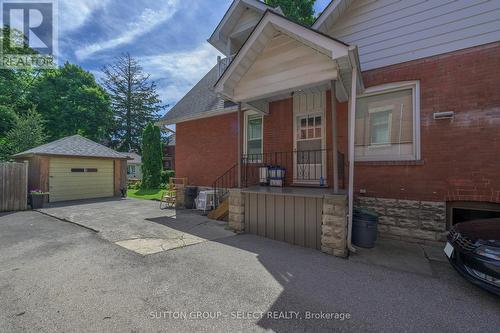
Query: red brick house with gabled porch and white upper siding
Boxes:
[{"xmin": 161, "ymin": 0, "xmax": 500, "ymax": 252}]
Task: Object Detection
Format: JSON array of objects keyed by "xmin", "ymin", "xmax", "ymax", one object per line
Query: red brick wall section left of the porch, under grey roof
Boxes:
[{"xmin": 175, "ymin": 113, "xmax": 237, "ymax": 186}]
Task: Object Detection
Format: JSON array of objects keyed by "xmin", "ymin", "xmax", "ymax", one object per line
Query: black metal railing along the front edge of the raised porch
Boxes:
[{"xmin": 241, "ymin": 149, "xmax": 345, "ymax": 188}]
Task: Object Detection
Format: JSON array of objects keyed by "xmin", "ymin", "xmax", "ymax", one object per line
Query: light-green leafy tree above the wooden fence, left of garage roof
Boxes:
[{"xmin": 5, "ymin": 109, "xmax": 47, "ymax": 154}]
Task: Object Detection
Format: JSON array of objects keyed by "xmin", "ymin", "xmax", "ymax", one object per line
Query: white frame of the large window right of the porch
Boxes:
[{"xmin": 355, "ymin": 80, "xmax": 421, "ymax": 162}]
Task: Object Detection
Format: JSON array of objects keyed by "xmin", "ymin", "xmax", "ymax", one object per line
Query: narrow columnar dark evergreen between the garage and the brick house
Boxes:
[{"xmin": 142, "ymin": 122, "xmax": 163, "ymax": 189}]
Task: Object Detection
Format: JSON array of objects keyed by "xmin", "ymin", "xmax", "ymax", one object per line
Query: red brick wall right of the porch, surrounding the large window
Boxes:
[{"xmin": 354, "ymin": 43, "xmax": 500, "ymax": 202}]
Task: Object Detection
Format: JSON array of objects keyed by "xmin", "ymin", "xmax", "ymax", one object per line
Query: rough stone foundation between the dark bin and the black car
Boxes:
[{"xmin": 355, "ymin": 196, "xmax": 447, "ymax": 243}]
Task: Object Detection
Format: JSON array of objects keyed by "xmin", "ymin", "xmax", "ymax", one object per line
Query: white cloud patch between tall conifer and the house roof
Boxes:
[{"xmin": 139, "ymin": 43, "xmax": 221, "ymax": 103}]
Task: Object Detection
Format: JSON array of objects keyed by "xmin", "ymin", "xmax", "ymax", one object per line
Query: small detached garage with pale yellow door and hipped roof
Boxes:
[{"xmin": 14, "ymin": 135, "xmax": 129, "ymax": 202}]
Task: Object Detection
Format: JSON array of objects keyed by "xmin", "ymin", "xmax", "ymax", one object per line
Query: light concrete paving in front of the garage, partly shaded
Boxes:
[{"xmin": 39, "ymin": 199, "xmax": 234, "ymax": 255}]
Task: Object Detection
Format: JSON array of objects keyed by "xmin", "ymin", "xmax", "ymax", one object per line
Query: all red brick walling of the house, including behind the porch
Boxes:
[{"xmin": 176, "ymin": 43, "xmax": 500, "ymax": 202}]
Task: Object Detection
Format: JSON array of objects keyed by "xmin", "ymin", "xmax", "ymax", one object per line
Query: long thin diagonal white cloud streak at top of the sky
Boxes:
[{"xmin": 75, "ymin": 0, "xmax": 178, "ymax": 60}]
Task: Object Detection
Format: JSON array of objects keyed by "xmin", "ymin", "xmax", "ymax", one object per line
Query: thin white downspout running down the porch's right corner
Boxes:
[{"xmin": 347, "ymin": 64, "xmax": 358, "ymax": 253}]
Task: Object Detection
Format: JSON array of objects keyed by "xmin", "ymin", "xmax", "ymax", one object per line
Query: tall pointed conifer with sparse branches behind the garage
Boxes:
[{"xmin": 102, "ymin": 53, "xmax": 164, "ymax": 151}]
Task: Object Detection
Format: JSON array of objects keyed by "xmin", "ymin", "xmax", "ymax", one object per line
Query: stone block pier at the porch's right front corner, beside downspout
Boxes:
[{"xmin": 321, "ymin": 194, "xmax": 348, "ymax": 257}]
